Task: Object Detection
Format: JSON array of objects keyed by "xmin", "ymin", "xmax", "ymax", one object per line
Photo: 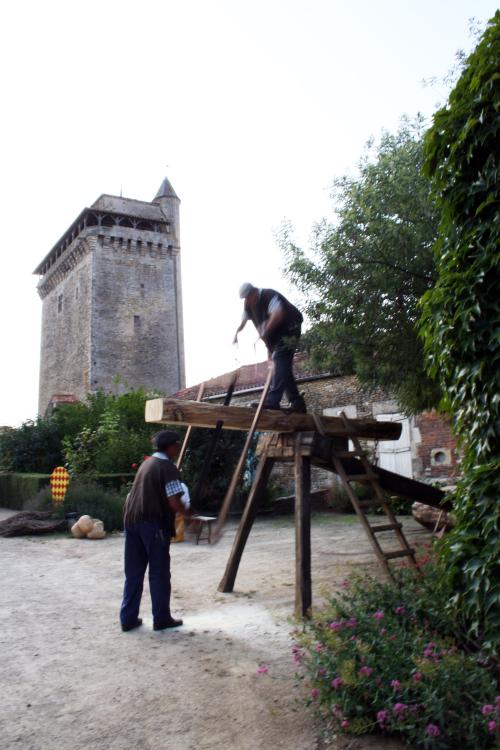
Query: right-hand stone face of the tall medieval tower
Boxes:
[{"xmin": 91, "ymin": 234, "xmax": 184, "ymax": 394}]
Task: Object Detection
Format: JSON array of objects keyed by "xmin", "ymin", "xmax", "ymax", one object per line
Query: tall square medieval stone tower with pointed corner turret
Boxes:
[{"xmin": 34, "ymin": 179, "xmax": 185, "ymax": 414}]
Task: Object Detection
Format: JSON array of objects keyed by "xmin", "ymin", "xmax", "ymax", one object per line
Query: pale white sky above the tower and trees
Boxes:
[{"xmin": 0, "ymin": 0, "xmax": 497, "ymax": 425}]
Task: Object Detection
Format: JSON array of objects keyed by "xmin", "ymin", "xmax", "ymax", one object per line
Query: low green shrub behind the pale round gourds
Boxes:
[{"xmin": 28, "ymin": 481, "xmax": 125, "ymax": 531}]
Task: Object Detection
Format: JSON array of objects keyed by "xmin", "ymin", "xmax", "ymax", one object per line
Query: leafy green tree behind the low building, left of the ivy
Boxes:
[{"xmin": 279, "ymin": 120, "xmax": 439, "ymax": 412}]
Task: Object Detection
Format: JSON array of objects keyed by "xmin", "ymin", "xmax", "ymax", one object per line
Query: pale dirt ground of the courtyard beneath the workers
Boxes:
[{"xmin": 0, "ymin": 511, "xmax": 426, "ymax": 750}]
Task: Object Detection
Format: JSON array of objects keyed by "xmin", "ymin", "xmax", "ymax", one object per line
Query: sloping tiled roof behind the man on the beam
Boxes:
[{"xmin": 170, "ymin": 352, "xmax": 330, "ymax": 401}]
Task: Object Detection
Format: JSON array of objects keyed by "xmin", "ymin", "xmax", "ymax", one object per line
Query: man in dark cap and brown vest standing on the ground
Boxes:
[{"xmin": 120, "ymin": 430, "xmax": 190, "ymax": 631}]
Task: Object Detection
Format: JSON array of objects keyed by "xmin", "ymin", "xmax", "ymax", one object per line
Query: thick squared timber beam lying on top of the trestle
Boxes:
[{"xmin": 146, "ymin": 398, "xmax": 401, "ymax": 440}]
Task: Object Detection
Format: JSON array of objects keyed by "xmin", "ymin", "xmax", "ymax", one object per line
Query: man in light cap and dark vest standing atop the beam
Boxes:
[{"xmin": 233, "ymin": 282, "xmax": 307, "ymax": 413}]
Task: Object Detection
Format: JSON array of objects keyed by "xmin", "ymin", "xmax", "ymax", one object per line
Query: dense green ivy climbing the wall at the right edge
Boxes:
[{"xmin": 421, "ymin": 12, "xmax": 500, "ymax": 650}]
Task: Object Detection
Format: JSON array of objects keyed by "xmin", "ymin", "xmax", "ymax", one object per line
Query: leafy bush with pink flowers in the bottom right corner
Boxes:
[{"xmin": 293, "ymin": 566, "xmax": 500, "ymax": 750}]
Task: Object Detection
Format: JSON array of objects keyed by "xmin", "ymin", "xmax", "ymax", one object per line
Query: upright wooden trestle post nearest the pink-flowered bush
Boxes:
[{"xmin": 295, "ymin": 434, "xmax": 312, "ymax": 617}]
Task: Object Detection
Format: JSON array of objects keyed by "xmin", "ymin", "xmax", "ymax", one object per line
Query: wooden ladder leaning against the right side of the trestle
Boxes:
[{"xmin": 314, "ymin": 412, "xmax": 418, "ymax": 578}]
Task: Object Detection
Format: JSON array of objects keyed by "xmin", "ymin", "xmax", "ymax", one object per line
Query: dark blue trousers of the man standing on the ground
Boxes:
[{"xmin": 120, "ymin": 521, "xmax": 170, "ymax": 625}]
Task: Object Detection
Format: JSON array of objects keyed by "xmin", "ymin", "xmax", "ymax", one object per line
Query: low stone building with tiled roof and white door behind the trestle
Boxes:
[{"xmin": 175, "ymin": 354, "xmax": 460, "ymax": 500}]
